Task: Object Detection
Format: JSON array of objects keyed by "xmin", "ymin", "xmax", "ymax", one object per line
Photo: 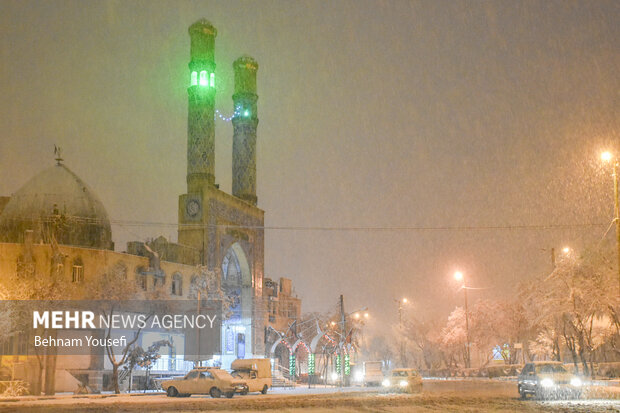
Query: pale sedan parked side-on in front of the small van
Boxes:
[{"xmin": 161, "ymin": 367, "xmax": 248, "ymax": 398}]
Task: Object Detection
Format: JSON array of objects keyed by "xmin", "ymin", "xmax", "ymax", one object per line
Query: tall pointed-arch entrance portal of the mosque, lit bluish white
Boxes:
[{"xmin": 221, "ymin": 242, "xmax": 253, "ymax": 368}]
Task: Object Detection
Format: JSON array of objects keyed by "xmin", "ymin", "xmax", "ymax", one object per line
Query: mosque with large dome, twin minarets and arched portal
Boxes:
[{"xmin": 0, "ymin": 19, "xmax": 301, "ymax": 391}]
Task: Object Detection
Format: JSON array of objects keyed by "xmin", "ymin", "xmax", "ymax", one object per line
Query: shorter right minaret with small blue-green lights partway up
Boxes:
[{"xmin": 232, "ymin": 56, "xmax": 258, "ymax": 205}]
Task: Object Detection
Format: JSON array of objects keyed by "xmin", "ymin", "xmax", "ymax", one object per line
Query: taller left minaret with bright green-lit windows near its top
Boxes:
[{"xmin": 187, "ymin": 19, "xmax": 217, "ymax": 193}]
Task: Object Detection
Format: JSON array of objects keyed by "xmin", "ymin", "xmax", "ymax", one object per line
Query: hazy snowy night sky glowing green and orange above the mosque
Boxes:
[{"xmin": 0, "ymin": 0, "xmax": 620, "ymax": 325}]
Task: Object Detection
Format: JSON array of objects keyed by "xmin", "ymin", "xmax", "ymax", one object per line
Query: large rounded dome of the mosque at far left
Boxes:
[{"xmin": 0, "ymin": 162, "xmax": 114, "ymax": 249}]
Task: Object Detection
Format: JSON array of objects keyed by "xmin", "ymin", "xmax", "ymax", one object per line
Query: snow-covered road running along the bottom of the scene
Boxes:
[{"xmin": 0, "ymin": 380, "xmax": 620, "ymax": 413}]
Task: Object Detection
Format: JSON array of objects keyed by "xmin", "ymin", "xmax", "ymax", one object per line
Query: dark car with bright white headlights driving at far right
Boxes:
[{"xmin": 517, "ymin": 361, "xmax": 583, "ymax": 399}]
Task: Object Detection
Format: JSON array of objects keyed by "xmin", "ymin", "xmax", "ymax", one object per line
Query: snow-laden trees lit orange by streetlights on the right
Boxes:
[{"xmin": 386, "ymin": 248, "xmax": 620, "ymax": 375}]
